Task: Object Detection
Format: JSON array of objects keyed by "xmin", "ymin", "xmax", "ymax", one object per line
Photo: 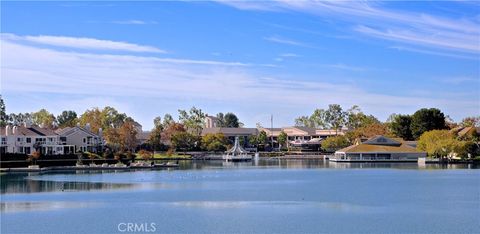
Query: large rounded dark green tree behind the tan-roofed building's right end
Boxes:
[{"xmin": 411, "ymin": 108, "xmax": 446, "ymax": 139}]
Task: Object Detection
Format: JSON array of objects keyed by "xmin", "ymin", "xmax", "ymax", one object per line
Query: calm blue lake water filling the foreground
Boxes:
[{"xmin": 0, "ymin": 159, "xmax": 480, "ymax": 233}]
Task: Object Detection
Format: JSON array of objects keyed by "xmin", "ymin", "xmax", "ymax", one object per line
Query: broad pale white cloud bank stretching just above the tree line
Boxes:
[{"xmin": 1, "ymin": 35, "xmax": 480, "ymax": 126}]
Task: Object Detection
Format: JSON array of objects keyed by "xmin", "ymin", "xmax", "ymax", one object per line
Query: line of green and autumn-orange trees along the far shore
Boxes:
[{"xmin": 0, "ymin": 95, "xmax": 480, "ymax": 158}]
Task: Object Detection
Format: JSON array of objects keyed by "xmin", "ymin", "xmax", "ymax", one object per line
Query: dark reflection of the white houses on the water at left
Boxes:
[{"xmin": 0, "ymin": 173, "xmax": 133, "ymax": 194}]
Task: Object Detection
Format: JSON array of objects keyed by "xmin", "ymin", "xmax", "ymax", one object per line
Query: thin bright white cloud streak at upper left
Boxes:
[{"xmin": 1, "ymin": 33, "xmax": 166, "ymax": 53}]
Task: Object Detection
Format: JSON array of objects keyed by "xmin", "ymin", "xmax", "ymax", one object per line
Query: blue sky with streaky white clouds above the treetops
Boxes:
[{"xmin": 1, "ymin": 1, "xmax": 480, "ymax": 129}]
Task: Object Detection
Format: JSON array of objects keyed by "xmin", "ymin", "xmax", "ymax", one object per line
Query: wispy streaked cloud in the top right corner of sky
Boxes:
[{"xmin": 218, "ymin": 1, "xmax": 480, "ymax": 54}]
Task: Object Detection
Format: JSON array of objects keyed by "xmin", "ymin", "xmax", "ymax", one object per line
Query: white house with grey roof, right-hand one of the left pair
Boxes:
[{"xmin": 55, "ymin": 124, "xmax": 103, "ymax": 154}]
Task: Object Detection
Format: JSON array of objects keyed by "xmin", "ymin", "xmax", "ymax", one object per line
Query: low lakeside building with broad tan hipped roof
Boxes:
[{"xmin": 330, "ymin": 136, "xmax": 427, "ymax": 162}]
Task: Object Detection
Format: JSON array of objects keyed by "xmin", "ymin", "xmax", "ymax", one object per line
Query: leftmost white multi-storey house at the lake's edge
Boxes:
[{"xmin": 0, "ymin": 124, "xmax": 74, "ymax": 155}]
